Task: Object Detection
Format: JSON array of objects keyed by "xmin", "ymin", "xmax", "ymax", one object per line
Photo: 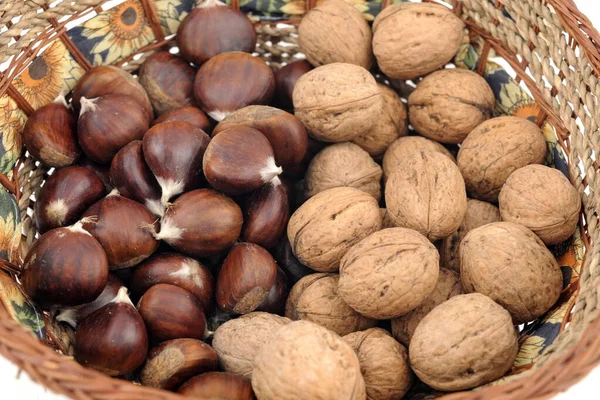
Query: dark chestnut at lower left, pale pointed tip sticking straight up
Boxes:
[{"xmin": 75, "ymin": 287, "xmax": 148, "ymax": 376}]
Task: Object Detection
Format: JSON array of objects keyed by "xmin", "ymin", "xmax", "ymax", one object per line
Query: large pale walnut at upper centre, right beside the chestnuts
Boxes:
[{"xmin": 292, "ymin": 63, "xmax": 383, "ymax": 142}]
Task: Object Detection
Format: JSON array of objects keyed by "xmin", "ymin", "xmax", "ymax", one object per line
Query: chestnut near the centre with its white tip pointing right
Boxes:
[{"xmin": 202, "ymin": 125, "xmax": 283, "ymax": 196}]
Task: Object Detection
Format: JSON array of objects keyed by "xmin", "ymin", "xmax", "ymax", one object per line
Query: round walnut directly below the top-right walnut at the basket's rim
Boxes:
[{"xmin": 408, "ymin": 68, "xmax": 496, "ymax": 143}]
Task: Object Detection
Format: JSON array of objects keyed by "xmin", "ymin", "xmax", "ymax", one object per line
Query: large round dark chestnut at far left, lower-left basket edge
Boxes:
[{"xmin": 21, "ymin": 221, "xmax": 108, "ymax": 308}]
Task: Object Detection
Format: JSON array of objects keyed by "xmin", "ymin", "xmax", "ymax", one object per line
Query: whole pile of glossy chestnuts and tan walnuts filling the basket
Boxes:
[{"xmin": 20, "ymin": 0, "xmax": 581, "ymax": 400}]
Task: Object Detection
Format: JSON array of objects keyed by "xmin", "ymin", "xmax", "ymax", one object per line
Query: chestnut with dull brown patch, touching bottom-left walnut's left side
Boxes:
[{"xmin": 140, "ymin": 339, "xmax": 219, "ymax": 390}]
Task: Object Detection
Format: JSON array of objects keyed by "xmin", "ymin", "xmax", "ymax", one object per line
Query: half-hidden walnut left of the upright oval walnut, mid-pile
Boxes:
[{"xmin": 305, "ymin": 143, "xmax": 383, "ymax": 201}]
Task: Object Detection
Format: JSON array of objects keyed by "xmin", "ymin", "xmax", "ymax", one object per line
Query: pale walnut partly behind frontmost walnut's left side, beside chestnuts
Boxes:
[{"xmin": 212, "ymin": 312, "xmax": 291, "ymax": 378}]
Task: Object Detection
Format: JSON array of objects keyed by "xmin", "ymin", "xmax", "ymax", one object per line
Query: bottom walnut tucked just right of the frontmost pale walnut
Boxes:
[{"xmin": 342, "ymin": 328, "xmax": 413, "ymax": 400}]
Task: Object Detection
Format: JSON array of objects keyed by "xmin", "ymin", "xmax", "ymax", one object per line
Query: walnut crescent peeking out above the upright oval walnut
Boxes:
[{"xmin": 382, "ymin": 136, "xmax": 456, "ymax": 182}]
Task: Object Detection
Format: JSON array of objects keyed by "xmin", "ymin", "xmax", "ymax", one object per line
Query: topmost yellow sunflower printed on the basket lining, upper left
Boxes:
[{"xmin": 82, "ymin": 0, "xmax": 154, "ymax": 65}]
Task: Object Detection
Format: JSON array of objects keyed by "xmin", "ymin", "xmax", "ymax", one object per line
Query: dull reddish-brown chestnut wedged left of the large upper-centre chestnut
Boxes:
[{"xmin": 139, "ymin": 51, "xmax": 196, "ymax": 115}]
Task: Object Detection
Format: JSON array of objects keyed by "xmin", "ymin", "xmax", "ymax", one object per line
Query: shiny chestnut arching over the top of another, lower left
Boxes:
[{"xmin": 130, "ymin": 253, "xmax": 215, "ymax": 315}]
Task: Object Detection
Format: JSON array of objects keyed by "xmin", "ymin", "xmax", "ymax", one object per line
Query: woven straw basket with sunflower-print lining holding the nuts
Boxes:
[{"xmin": 0, "ymin": 0, "xmax": 600, "ymax": 400}]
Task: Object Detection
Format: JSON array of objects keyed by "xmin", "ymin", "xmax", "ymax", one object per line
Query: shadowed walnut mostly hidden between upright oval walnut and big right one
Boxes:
[{"xmin": 440, "ymin": 199, "xmax": 502, "ymax": 272}]
